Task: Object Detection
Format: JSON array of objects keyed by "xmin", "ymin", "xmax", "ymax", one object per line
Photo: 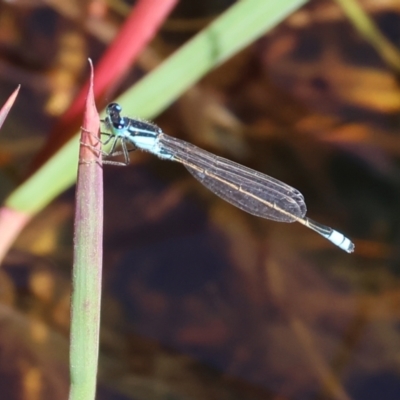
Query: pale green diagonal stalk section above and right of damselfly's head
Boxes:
[{"xmin": 117, "ymin": 0, "xmax": 306, "ymax": 119}]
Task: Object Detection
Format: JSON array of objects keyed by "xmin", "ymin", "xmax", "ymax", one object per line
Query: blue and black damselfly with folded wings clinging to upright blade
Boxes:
[{"xmin": 104, "ymin": 103, "xmax": 354, "ymax": 253}]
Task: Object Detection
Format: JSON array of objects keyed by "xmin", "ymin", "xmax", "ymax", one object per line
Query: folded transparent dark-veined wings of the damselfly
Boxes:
[{"xmin": 158, "ymin": 134, "xmax": 307, "ymax": 222}]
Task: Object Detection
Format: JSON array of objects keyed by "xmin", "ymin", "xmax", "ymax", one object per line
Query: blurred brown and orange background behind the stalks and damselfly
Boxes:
[{"xmin": 0, "ymin": 0, "xmax": 400, "ymax": 400}]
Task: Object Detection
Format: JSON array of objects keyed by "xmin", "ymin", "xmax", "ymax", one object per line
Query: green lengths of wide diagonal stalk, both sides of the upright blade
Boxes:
[{"xmin": 6, "ymin": 0, "xmax": 307, "ymax": 214}]
